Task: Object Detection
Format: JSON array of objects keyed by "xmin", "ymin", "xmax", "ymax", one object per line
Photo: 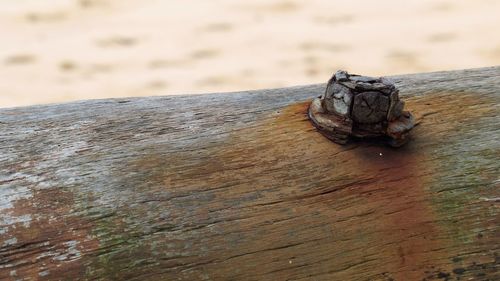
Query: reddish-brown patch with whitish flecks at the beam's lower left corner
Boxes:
[{"xmin": 0, "ymin": 188, "xmax": 99, "ymax": 280}]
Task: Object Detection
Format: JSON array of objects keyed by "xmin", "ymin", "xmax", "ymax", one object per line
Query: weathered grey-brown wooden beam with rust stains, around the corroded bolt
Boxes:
[{"xmin": 0, "ymin": 67, "xmax": 500, "ymax": 280}]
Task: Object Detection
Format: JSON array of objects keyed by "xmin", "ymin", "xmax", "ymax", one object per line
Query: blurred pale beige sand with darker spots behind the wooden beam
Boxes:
[{"xmin": 0, "ymin": 0, "xmax": 500, "ymax": 107}]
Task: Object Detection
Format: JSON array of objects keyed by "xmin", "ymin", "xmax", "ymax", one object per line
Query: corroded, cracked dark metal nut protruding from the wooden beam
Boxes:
[{"xmin": 309, "ymin": 70, "xmax": 415, "ymax": 147}]
